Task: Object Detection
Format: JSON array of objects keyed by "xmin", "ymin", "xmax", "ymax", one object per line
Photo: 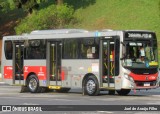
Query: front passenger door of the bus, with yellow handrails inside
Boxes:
[{"xmin": 100, "ymin": 36, "xmax": 120, "ymax": 88}]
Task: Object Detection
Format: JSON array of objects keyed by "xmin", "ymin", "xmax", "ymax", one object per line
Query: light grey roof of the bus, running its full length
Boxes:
[{"xmin": 3, "ymin": 29, "xmax": 156, "ymax": 40}]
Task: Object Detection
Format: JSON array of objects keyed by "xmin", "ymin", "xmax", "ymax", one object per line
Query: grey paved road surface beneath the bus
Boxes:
[{"xmin": 0, "ymin": 85, "xmax": 160, "ymax": 114}]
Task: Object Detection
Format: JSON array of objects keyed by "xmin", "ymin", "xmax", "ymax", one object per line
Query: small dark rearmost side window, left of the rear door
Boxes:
[{"xmin": 5, "ymin": 41, "xmax": 13, "ymax": 59}]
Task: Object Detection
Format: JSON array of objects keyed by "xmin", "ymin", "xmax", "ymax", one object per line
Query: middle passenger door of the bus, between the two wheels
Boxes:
[{"xmin": 47, "ymin": 41, "xmax": 62, "ymax": 85}]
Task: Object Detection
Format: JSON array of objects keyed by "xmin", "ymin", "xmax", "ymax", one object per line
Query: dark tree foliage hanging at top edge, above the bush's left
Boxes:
[{"xmin": 13, "ymin": 0, "xmax": 39, "ymax": 14}]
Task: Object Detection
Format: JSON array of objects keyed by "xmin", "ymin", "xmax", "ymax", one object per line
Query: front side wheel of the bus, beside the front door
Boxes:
[{"xmin": 83, "ymin": 76, "xmax": 99, "ymax": 96}]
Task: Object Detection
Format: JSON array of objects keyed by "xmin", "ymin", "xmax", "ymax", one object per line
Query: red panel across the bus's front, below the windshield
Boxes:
[{"xmin": 129, "ymin": 72, "xmax": 158, "ymax": 81}]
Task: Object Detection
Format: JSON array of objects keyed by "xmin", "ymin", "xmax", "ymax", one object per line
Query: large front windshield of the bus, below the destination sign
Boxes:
[{"xmin": 123, "ymin": 40, "xmax": 158, "ymax": 68}]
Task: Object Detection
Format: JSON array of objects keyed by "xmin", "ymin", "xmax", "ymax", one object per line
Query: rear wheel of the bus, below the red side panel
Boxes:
[{"xmin": 27, "ymin": 75, "xmax": 41, "ymax": 93}]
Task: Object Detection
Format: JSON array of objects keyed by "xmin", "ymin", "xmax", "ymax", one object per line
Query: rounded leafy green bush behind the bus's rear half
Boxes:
[{"xmin": 15, "ymin": 4, "xmax": 74, "ymax": 34}]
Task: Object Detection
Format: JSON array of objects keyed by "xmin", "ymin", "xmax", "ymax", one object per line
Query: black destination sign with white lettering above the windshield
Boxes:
[{"xmin": 125, "ymin": 32, "xmax": 155, "ymax": 38}]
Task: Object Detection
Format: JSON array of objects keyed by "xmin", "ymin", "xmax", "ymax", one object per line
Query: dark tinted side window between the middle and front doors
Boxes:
[{"xmin": 63, "ymin": 38, "xmax": 99, "ymax": 59}]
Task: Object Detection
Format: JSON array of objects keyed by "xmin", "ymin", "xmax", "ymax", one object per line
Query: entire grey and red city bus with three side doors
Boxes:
[{"xmin": 1, "ymin": 29, "xmax": 159, "ymax": 96}]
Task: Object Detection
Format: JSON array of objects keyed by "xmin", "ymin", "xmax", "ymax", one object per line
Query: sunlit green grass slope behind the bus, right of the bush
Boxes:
[{"xmin": 73, "ymin": 0, "xmax": 160, "ymax": 40}]
